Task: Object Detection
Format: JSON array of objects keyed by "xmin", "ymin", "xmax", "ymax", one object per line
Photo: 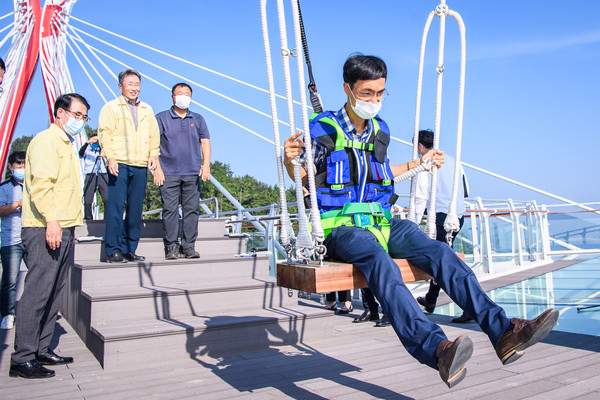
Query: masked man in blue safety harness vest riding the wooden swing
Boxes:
[{"xmin": 284, "ymin": 54, "xmax": 558, "ymax": 387}]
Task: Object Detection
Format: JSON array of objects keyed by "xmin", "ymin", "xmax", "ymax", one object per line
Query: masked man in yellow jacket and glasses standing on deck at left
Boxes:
[{"xmin": 9, "ymin": 93, "xmax": 90, "ymax": 379}]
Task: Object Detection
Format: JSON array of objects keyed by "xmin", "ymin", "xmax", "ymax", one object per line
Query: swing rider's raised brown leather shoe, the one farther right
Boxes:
[{"xmin": 494, "ymin": 308, "xmax": 558, "ymax": 365}]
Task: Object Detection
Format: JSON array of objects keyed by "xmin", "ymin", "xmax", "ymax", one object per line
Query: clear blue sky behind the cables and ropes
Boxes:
[{"xmin": 0, "ymin": 0, "xmax": 600, "ymax": 209}]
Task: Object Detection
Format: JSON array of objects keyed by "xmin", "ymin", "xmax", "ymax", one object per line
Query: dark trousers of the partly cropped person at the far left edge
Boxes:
[{"xmin": 0, "ymin": 243, "xmax": 25, "ymax": 317}]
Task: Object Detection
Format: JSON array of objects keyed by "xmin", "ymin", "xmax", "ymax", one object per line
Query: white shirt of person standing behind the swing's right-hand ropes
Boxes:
[{"xmin": 415, "ymin": 155, "xmax": 466, "ymax": 223}]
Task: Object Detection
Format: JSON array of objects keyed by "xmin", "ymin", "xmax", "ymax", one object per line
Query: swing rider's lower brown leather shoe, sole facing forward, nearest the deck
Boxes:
[{"xmin": 435, "ymin": 335, "xmax": 473, "ymax": 388}]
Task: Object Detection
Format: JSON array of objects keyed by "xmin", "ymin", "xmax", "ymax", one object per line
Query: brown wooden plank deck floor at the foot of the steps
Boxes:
[{"xmin": 0, "ymin": 263, "xmax": 600, "ymax": 400}]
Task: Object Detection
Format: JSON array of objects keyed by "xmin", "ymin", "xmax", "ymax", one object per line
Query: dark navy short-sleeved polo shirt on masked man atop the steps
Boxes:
[{"xmin": 156, "ymin": 107, "xmax": 210, "ymax": 175}]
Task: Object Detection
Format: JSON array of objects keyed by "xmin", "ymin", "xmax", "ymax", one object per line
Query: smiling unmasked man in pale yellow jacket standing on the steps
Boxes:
[{"xmin": 98, "ymin": 69, "xmax": 160, "ymax": 262}]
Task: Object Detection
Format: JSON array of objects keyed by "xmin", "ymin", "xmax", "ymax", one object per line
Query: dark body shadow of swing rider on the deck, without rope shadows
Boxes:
[{"xmin": 187, "ymin": 316, "xmax": 411, "ymax": 400}]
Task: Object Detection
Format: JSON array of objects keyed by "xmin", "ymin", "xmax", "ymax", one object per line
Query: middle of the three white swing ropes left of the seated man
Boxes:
[{"xmin": 277, "ymin": 0, "xmax": 313, "ymax": 262}]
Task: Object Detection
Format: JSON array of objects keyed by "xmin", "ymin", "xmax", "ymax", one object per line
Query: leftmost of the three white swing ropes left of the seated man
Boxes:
[{"xmin": 260, "ymin": 0, "xmax": 294, "ymax": 250}]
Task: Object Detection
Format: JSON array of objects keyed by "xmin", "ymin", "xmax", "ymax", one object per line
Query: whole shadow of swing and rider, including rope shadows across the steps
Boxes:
[{"xmin": 134, "ymin": 263, "xmax": 411, "ymax": 400}]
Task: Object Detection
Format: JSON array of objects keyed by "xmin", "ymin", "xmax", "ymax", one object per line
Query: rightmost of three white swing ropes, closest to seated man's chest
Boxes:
[{"xmin": 291, "ymin": 0, "xmax": 325, "ymax": 246}]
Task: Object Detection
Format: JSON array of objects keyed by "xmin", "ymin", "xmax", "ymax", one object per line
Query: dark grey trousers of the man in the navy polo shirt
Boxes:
[{"xmin": 160, "ymin": 175, "xmax": 200, "ymax": 249}]
